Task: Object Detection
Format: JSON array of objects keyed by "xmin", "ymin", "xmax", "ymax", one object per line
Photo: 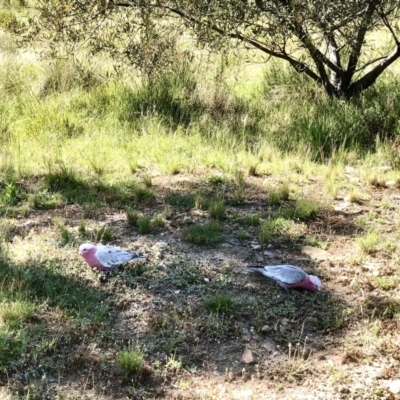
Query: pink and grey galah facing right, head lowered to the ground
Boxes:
[{"xmin": 247, "ymin": 265, "xmax": 322, "ymax": 292}]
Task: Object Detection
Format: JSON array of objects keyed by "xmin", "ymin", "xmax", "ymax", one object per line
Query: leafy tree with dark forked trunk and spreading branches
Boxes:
[{"xmin": 27, "ymin": 0, "xmax": 400, "ymax": 98}]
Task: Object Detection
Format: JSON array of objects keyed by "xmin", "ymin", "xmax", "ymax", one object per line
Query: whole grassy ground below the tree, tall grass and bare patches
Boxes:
[{"xmin": 0, "ymin": 22, "xmax": 400, "ymax": 399}]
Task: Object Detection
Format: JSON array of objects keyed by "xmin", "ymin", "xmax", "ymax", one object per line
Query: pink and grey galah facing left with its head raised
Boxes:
[{"xmin": 79, "ymin": 243, "xmax": 146, "ymax": 272}]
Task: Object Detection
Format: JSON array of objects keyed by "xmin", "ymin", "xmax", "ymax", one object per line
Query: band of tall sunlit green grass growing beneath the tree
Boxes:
[{"xmin": 0, "ymin": 43, "xmax": 400, "ymax": 180}]
